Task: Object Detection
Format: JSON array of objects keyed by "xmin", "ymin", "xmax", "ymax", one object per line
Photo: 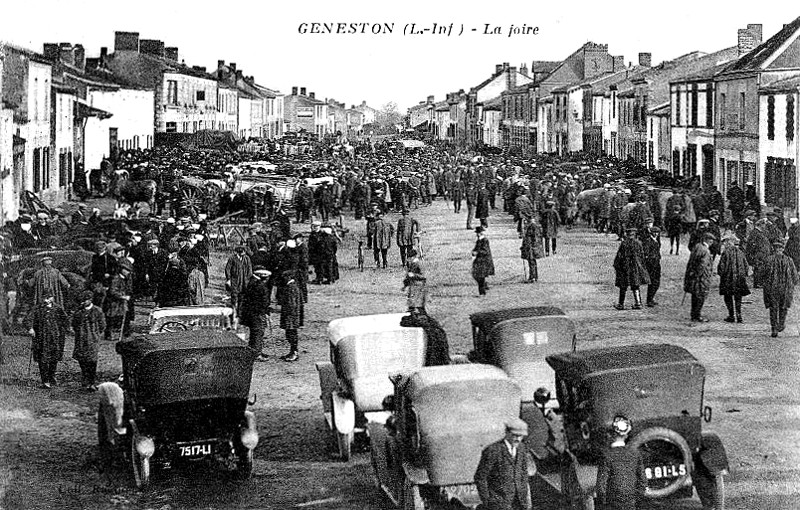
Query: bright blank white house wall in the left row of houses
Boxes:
[{"xmin": 84, "ymin": 88, "xmax": 155, "ymax": 171}]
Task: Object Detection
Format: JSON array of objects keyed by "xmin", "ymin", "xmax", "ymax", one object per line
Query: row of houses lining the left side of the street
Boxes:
[{"xmin": 0, "ymin": 32, "xmax": 377, "ymax": 224}]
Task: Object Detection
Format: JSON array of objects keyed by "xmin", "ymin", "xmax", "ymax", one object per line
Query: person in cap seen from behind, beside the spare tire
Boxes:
[{"xmin": 596, "ymin": 416, "xmax": 647, "ymax": 510}]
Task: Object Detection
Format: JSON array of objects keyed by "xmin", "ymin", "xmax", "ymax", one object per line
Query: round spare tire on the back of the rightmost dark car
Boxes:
[{"xmin": 628, "ymin": 427, "xmax": 692, "ymax": 499}]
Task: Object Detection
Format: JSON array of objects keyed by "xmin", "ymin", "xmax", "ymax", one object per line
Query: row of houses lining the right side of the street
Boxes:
[{"xmin": 408, "ymin": 18, "xmax": 800, "ymax": 212}]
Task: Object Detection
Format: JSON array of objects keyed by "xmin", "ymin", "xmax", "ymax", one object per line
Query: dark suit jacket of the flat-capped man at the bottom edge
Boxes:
[{"xmin": 475, "ymin": 439, "xmax": 531, "ymax": 510}]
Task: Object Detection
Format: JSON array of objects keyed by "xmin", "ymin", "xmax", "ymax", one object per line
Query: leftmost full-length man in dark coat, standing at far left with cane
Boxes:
[{"xmin": 24, "ymin": 293, "xmax": 69, "ymax": 389}]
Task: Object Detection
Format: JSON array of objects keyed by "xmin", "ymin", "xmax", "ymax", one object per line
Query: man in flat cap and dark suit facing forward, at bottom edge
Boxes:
[{"xmin": 474, "ymin": 417, "xmax": 531, "ymax": 510}]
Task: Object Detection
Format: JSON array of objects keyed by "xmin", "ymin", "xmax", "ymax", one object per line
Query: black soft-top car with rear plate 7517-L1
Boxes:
[{"xmin": 97, "ymin": 330, "xmax": 258, "ymax": 487}]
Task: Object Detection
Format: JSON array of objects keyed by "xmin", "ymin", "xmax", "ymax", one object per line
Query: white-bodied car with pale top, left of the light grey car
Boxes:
[{"xmin": 316, "ymin": 313, "xmax": 427, "ymax": 460}]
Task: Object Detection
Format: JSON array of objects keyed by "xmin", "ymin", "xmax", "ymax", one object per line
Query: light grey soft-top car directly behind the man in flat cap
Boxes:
[{"xmin": 368, "ymin": 364, "xmax": 520, "ymax": 510}]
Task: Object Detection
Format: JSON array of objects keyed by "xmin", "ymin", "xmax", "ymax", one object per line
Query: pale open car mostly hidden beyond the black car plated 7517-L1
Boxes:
[{"xmin": 148, "ymin": 305, "xmax": 234, "ymax": 335}]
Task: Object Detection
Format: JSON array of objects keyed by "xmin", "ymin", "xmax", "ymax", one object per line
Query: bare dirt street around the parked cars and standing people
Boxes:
[{"xmin": 0, "ymin": 200, "xmax": 800, "ymax": 510}]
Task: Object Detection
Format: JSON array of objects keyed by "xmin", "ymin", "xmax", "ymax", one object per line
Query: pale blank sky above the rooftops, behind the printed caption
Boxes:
[{"xmin": 0, "ymin": 0, "xmax": 800, "ymax": 112}]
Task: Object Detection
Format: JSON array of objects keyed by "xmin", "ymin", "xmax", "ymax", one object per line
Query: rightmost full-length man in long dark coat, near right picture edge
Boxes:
[{"xmin": 763, "ymin": 240, "xmax": 798, "ymax": 338}]
